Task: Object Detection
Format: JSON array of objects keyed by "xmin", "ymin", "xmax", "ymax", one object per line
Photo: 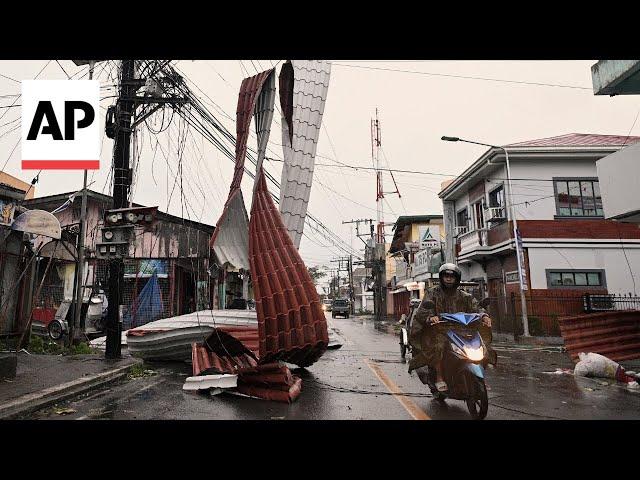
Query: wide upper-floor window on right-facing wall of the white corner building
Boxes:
[{"xmin": 553, "ymin": 179, "xmax": 604, "ymax": 217}]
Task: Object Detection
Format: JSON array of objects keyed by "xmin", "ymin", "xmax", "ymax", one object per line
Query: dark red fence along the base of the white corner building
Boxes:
[{"xmin": 488, "ymin": 293, "xmax": 640, "ymax": 337}]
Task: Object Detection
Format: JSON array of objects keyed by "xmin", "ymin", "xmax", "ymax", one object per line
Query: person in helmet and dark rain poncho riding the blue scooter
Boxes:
[{"xmin": 409, "ymin": 263, "xmax": 496, "ymax": 392}]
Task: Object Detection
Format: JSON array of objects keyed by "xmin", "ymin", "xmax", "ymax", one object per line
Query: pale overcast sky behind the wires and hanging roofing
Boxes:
[{"xmin": 0, "ymin": 60, "xmax": 640, "ymax": 284}]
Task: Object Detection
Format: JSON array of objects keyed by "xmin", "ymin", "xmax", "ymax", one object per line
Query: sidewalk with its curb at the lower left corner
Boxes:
[{"xmin": 0, "ymin": 352, "xmax": 142, "ymax": 419}]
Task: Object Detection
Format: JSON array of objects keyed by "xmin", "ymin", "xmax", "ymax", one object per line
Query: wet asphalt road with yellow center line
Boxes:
[{"xmin": 23, "ymin": 317, "xmax": 640, "ymax": 420}]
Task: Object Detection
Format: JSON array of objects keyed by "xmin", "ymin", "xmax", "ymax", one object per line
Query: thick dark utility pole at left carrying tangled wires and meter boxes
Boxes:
[{"xmin": 105, "ymin": 60, "xmax": 138, "ymax": 358}]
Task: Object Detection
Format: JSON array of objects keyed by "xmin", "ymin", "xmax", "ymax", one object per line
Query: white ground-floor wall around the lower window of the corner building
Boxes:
[{"xmin": 528, "ymin": 244, "xmax": 640, "ymax": 294}]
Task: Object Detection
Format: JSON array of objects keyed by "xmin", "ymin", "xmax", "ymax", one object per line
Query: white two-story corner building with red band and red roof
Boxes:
[{"xmin": 439, "ymin": 133, "xmax": 640, "ymax": 333}]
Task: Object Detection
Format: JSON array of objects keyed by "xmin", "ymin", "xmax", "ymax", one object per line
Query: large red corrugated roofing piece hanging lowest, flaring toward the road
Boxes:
[{"xmin": 249, "ymin": 169, "xmax": 329, "ymax": 367}]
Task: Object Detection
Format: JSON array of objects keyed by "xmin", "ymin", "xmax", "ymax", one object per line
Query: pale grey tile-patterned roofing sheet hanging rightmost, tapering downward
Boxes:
[{"xmin": 280, "ymin": 60, "xmax": 331, "ymax": 248}]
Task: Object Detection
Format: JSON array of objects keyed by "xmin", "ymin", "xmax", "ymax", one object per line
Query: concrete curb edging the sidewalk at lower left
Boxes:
[{"xmin": 0, "ymin": 361, "xmax": 142, "ymax": 420}]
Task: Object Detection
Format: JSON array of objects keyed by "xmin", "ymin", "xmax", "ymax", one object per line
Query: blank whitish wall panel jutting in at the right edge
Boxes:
[{"xmin": 597, "ymin": 143, "xmax": 640, "ymax": 223}]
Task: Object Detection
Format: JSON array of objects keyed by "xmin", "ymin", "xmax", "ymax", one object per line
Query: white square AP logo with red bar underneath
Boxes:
[{"xmin": 22, "ymin": 80, "xmax": 100, "ymax": 170}]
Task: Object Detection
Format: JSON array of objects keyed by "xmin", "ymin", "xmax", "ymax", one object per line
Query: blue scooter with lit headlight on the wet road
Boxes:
[{"xmin": 416, "ymin": 299, "xmax": 489, "ymax": 420}]
